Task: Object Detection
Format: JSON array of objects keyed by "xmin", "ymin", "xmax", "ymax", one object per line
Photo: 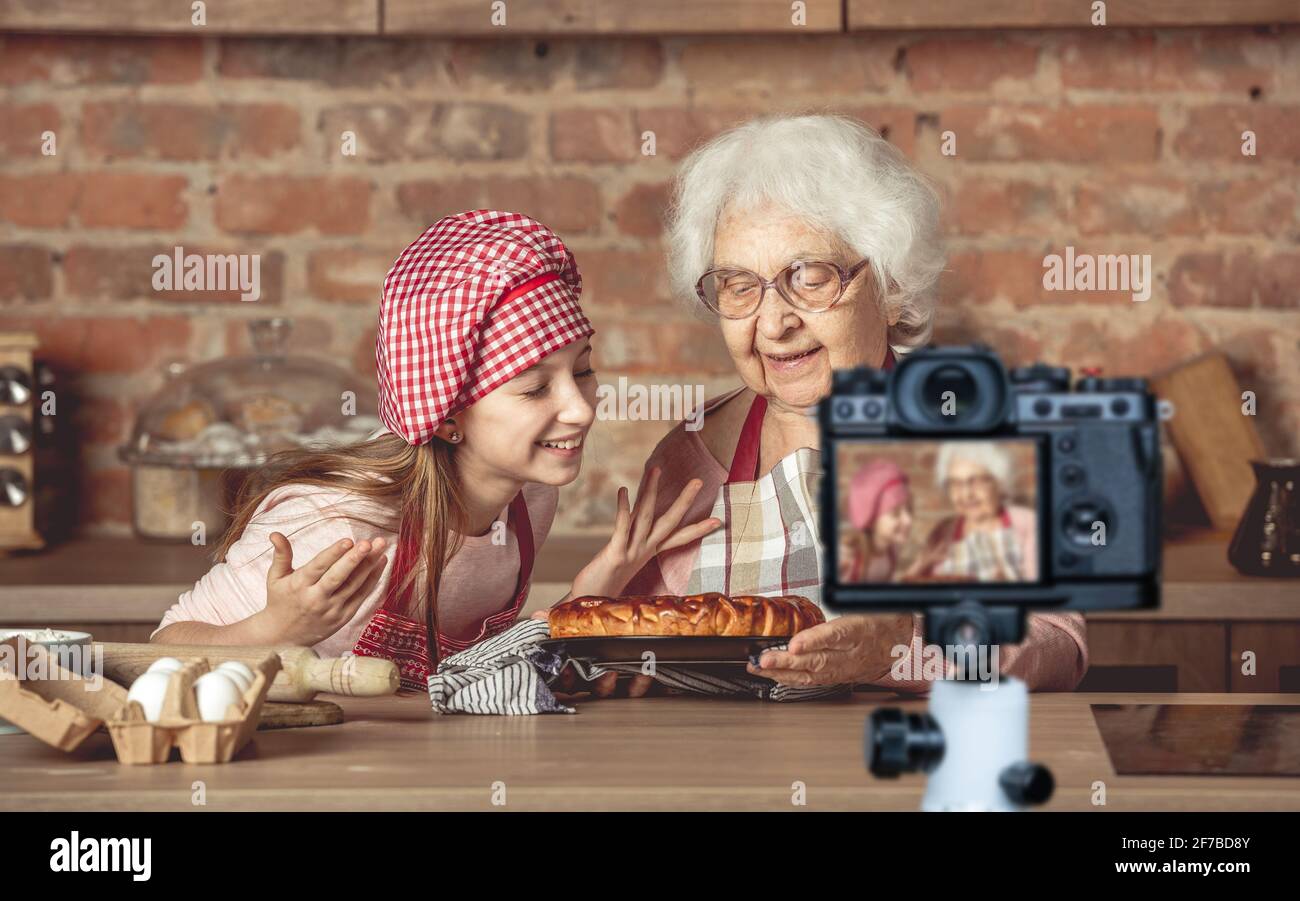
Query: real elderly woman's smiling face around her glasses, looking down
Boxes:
[{"xmin": 714, "ymin": 203, "xmax": 888, "ymax": 407}]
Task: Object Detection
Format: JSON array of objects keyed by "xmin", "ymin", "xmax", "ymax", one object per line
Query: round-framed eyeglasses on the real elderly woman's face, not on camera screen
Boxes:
[{"xmin": 696, "ymin": 259, "xmax": 868, "ymax": 319}]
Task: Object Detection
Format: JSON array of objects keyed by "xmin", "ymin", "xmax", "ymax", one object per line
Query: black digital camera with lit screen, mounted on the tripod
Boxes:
[{"xmin": 818, "ymin": 345, "xmax": 1162, "ymax": 641}]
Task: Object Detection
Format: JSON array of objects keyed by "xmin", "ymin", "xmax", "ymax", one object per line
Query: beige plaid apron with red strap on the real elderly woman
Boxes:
[{"xmin": 686, "ymin": 351, "xmax": 894, "ymax": 608}]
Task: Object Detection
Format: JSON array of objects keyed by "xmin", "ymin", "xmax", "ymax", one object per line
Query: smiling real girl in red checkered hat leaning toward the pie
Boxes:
[{"xmin": 151, "ymin": 209, "xmax": 720, "ymax": 690}]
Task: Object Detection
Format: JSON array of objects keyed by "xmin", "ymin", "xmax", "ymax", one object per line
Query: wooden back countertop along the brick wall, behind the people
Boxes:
[{"xmin": 0, "ymin": 532, "xmax": 1300, "ymax": 625}]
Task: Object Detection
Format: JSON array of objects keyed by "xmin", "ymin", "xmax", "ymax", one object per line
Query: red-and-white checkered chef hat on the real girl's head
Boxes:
[{"xmin": 374, "ymin": 209, "xmax": 595, "ymax": 446}]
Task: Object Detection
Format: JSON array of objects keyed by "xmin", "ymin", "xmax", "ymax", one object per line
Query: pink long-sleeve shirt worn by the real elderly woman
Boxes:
[{"xmin": 623, "ymin": 395, "xmax": 1088, "ymax": 693}]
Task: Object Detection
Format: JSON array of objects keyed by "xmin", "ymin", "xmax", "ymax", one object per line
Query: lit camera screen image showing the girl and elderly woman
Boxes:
[{"xmin": 835, "ymin": 438, "xmax": 1039, "ymax": 585}]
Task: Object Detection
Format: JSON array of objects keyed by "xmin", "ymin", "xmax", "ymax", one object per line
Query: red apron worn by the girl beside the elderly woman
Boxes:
[{"xmin": 352, "ymin": 491, "xmax": 533, "ymax": 692}]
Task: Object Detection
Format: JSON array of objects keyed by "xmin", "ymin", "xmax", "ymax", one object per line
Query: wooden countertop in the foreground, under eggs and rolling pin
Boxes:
[{"xmin": 0, "ymin": 693, "xmax": 1300, "ymax": 811}]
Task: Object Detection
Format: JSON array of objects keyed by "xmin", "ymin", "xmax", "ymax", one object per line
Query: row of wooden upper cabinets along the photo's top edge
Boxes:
[{"xmin": 0, "ymin": 0, "xmax": 1300, "ymax": 36}]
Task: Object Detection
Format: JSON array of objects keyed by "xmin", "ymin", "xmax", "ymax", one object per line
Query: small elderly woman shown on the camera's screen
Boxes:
[{"xmin": 905, "ymin": 441, "xmax": 1039, "ymax": 582}]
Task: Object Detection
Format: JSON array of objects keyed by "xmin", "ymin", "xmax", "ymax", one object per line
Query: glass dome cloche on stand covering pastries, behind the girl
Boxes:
[{"xmin": 120, "ymin": 319, "xmax": 381, "ymax": 540}]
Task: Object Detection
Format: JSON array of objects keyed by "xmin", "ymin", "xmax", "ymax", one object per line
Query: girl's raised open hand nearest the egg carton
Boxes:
[{"xmin": 259, "ymin": 532, "xmax": 387, "ymax": 645}]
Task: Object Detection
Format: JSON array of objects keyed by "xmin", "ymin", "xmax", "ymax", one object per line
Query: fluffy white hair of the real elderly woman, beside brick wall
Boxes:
[{"xmin": 667, "ymin": 114, "xmax": 945, "ymax": 352}]
